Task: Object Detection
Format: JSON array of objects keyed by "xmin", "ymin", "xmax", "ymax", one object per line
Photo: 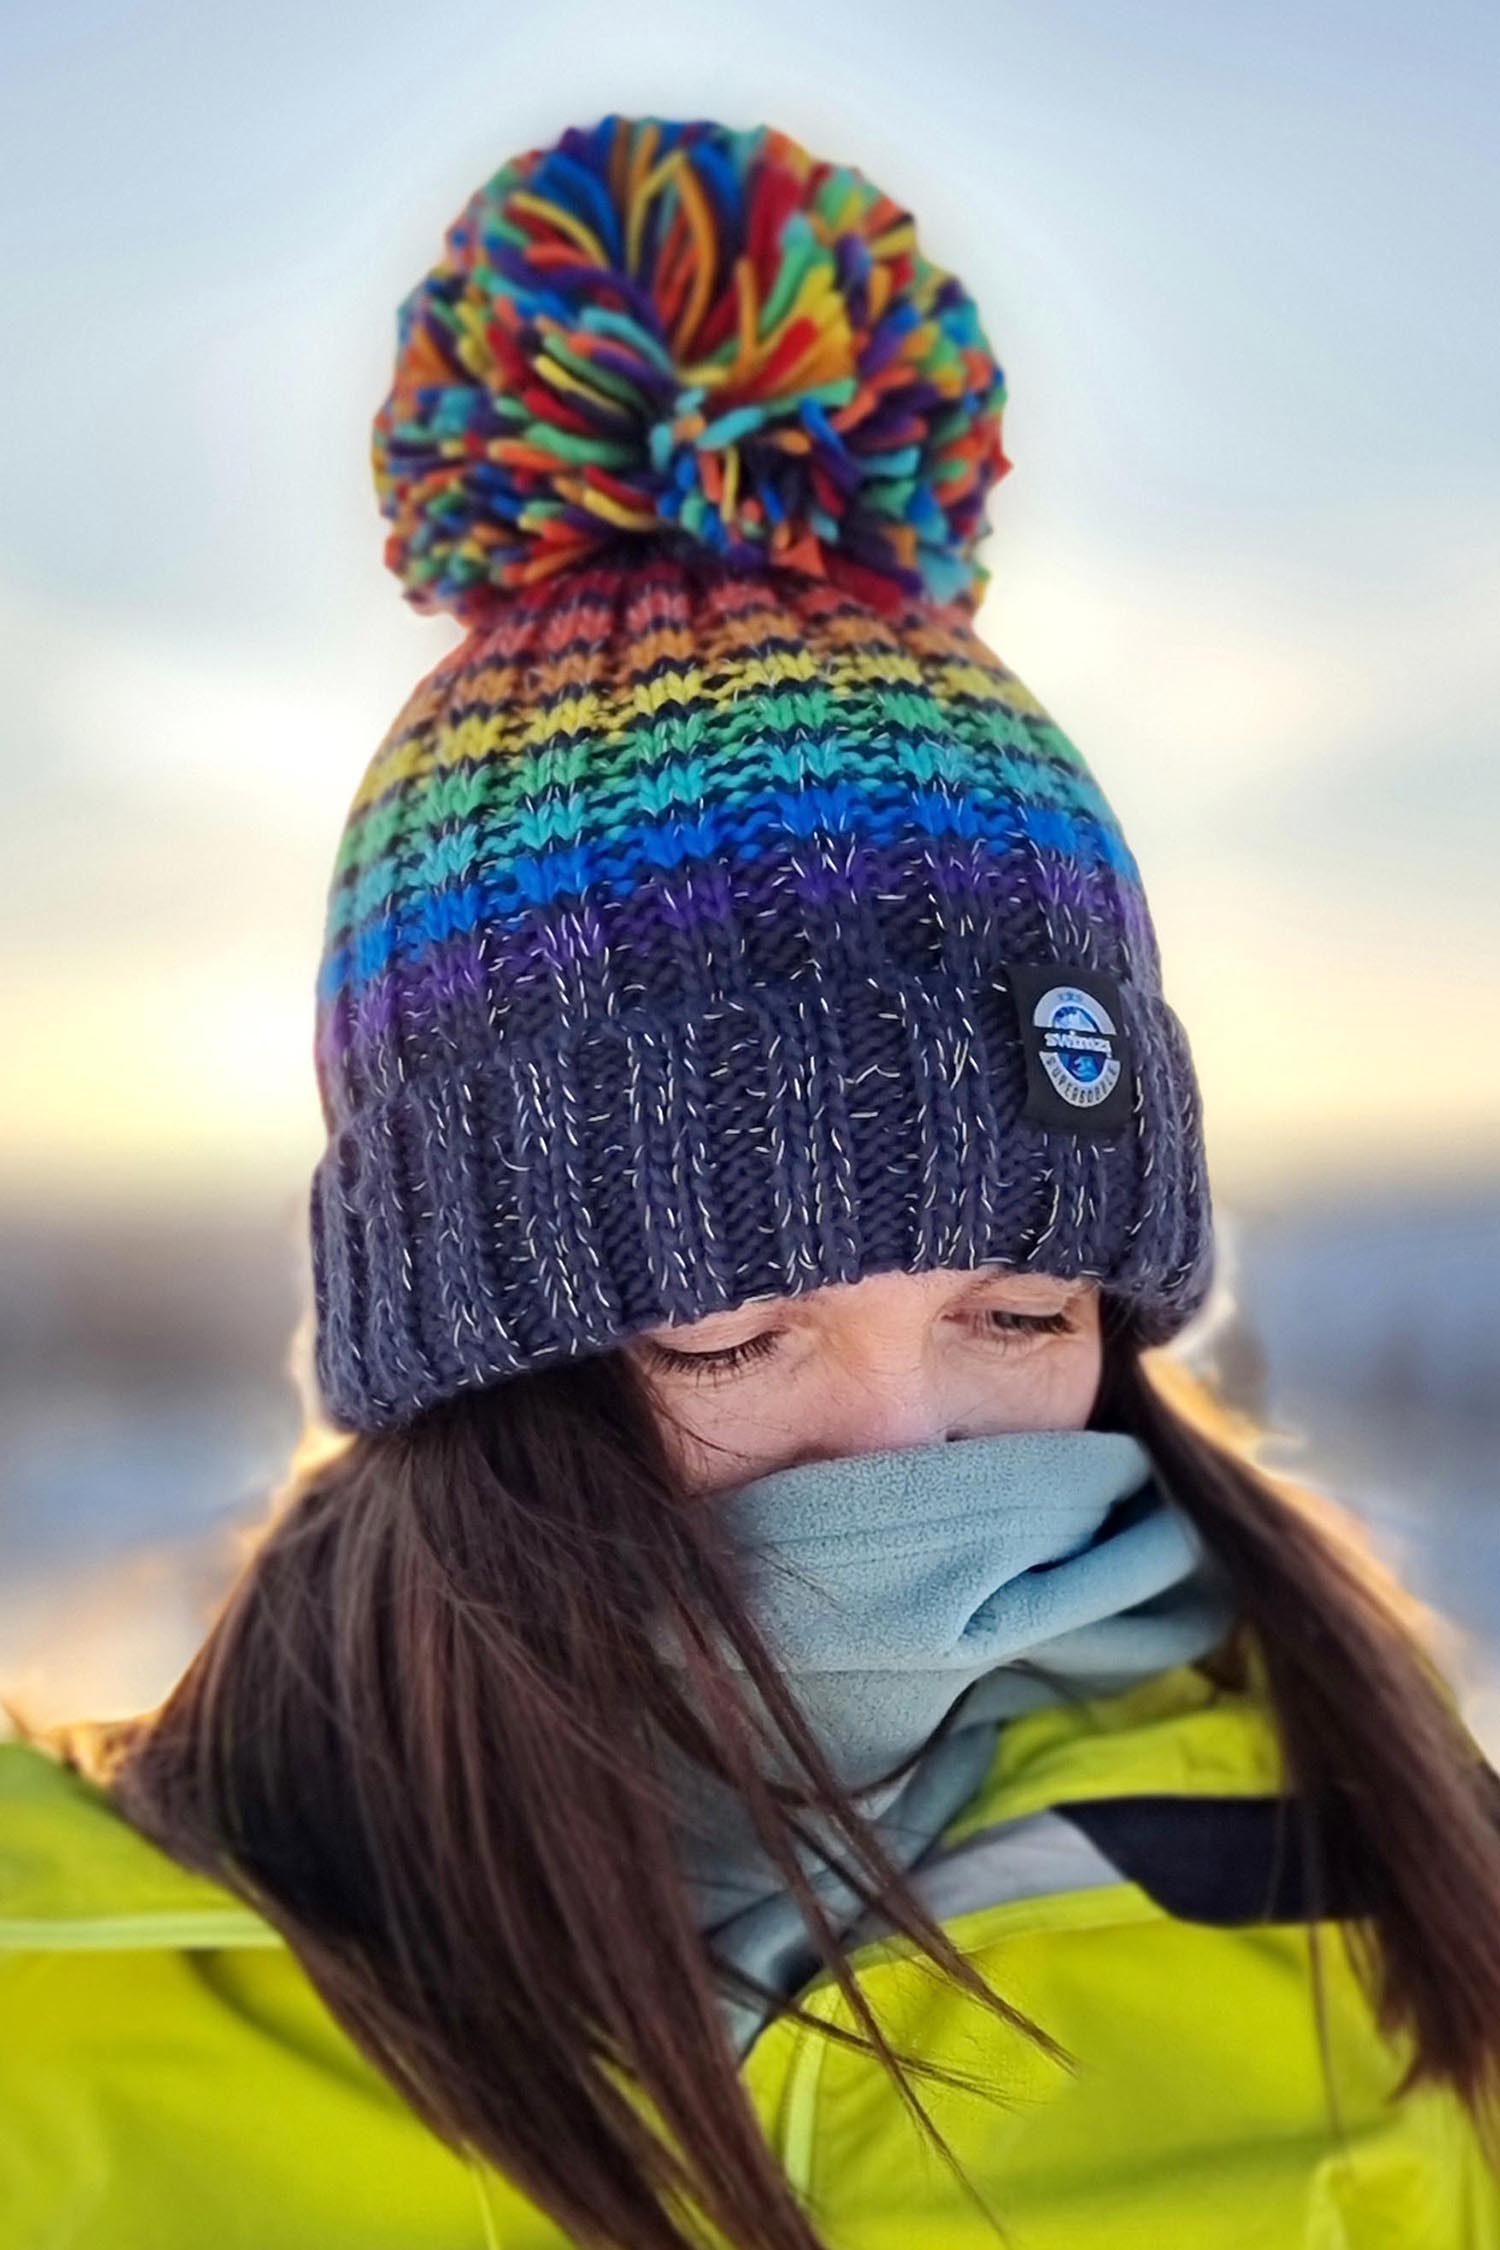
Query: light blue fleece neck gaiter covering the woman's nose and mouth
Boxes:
[{"xmin": 668, "ymin": 1429, "xmax": 1235, "ymax": 2050}]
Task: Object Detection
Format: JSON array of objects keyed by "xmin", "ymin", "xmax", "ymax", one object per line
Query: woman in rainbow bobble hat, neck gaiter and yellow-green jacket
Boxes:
[{"xmin": 0, "ymin": 117, "xmax": 1500, "ymax": 2250}]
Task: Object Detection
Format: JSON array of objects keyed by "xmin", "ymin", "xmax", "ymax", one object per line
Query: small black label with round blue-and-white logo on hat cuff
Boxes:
[{"xmin": 1005, "ymin": 961, "xmax": 1136, "ymax": 1134}]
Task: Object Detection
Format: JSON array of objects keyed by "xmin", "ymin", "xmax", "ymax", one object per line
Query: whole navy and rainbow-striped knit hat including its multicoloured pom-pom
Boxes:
[{"xmin": 308, "ymin": 117, "xmax": 1212, "ymax": 1431}]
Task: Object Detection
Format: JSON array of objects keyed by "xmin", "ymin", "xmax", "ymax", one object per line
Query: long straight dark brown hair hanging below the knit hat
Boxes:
[{"xmin": 41, "ymin": 1296, "xmax": 1500, "ymax": 2250}]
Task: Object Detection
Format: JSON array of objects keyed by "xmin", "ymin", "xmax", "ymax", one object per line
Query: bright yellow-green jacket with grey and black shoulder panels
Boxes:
[{"xmin": 0, "ymin": 1665, "xmax": 1500, "ymax": 2250}]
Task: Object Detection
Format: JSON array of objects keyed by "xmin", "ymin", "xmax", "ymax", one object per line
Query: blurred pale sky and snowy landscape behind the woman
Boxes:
[{"xmin": 0, "ymin": 0, "xmax": 1500, "ymax": 1755}]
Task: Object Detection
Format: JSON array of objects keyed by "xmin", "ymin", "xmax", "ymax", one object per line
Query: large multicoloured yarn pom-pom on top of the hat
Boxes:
[{"xmin": 373, "ymin": 117, "xmax": 1010, "ymax": 619}]
